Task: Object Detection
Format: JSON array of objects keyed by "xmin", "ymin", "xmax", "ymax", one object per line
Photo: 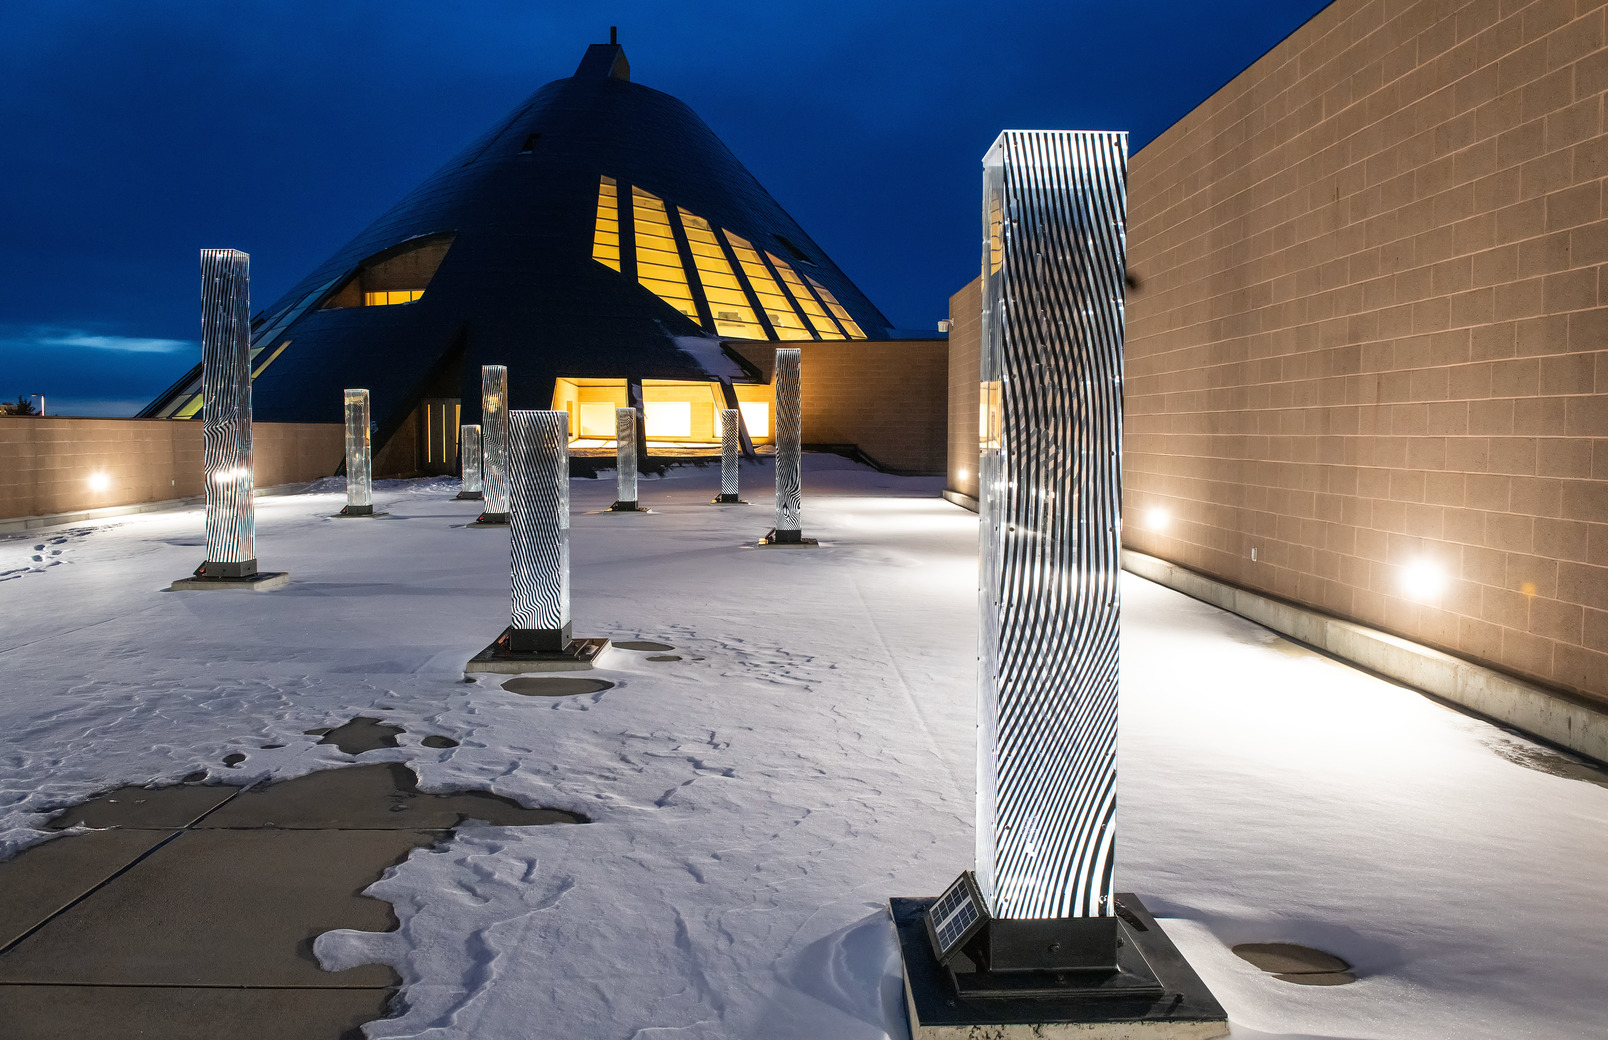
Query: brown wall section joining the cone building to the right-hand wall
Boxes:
[{"xmin": 732, "ymin": 339, "xmax": 949, "ymax": 474}]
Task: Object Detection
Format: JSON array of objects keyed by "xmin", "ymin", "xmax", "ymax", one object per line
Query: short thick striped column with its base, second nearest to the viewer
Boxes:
[{"xmin": 466, "ymin": 410, "xmax": 608, "ymax": 672}]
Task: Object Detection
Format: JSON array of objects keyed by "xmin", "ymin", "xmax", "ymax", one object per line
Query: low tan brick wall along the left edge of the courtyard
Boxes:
[{"xmin": 0, "ymin": 416, "xmax": 346, "ymax": 519}]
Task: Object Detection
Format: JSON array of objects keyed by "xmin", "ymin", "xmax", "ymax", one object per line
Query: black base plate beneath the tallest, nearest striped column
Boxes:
[{"xmin": 888, "ymin": 892, "xmax": 1229, "ymax": 1040}]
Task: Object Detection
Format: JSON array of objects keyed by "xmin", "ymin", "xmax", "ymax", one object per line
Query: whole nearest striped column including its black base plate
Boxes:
[{"xmin": 894, "ymin": 130, "xmax": 1227, "ymax": 1038}]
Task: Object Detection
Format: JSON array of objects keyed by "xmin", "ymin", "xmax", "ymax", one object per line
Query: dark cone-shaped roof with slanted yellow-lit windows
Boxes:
[{"xmin": 142, "ymin": 43, "xmax": 888, "ymax": 442}]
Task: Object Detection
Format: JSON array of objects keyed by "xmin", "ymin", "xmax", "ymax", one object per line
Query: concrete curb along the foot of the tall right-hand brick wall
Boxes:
[{"xmin": 1122, "ymin": 550, "xmax": 1608, "ymax": 762}]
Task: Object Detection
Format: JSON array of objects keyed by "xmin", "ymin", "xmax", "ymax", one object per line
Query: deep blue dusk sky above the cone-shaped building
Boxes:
[{"xmin": 0, "ymin": 0, "xmax": 1325, "ymax": 415}]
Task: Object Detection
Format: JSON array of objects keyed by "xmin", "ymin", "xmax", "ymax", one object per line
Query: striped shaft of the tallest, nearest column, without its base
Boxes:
[{"xmin": 976, "ymin": 130, "xmax": 1127, "ymax": 918}]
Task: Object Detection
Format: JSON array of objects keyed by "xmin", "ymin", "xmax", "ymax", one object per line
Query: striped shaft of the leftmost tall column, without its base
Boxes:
[{"xmin": 201, "ymin": 249, "xmax": 257, "ymax": 563}]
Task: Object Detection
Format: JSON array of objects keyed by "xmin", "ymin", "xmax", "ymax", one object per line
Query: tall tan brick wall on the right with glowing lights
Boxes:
[{"xmin": 1124, "ymin": 0, "xmax": 1608, "ymax": 699}]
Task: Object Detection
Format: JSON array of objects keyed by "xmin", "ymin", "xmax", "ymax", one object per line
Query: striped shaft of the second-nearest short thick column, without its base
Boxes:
[{"xmin": 507, "ymin": 408, "xmax": 569, "ymax": 632}]
